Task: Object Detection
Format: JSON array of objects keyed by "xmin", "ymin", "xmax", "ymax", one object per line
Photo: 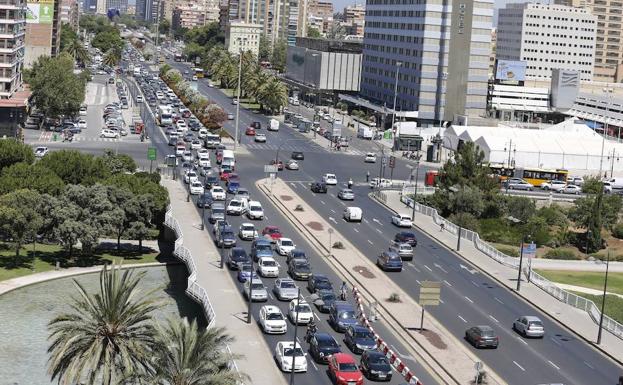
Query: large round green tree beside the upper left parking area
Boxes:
[{"xmin": 29, "ymin": 53, "xmax": 86, "ymax": 118}]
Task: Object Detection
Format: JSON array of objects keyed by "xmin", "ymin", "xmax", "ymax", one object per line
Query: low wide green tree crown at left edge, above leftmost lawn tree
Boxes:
[{"xmin": 0, "ymin": 162, "xmax": 65, "ymax": 196}]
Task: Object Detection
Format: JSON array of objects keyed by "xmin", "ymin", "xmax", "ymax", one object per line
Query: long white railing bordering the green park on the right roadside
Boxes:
[{"xmin": 398, "ymin": 189, "xmax": 623, "ymax": 339}]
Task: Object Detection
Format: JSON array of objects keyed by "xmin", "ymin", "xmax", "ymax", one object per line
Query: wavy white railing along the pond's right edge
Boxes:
[{"xmin": 164, "ymin": 209, "xmax": 216, "ymax": 328}]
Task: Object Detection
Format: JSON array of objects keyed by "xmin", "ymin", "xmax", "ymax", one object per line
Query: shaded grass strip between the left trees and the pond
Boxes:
[{"xmin": 0, "ymin": 243, "xmax": 160, "ymax": 281}]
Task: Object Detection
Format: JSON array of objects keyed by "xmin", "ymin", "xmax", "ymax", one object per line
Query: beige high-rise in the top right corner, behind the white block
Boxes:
[{"xmin": 555, "ymin": 0, "xmax": 623, "ymax": 83}]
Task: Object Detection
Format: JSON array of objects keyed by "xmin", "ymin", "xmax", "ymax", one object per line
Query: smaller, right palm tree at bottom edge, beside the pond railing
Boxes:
[{"xmin": 142, "ymin": 318, "xmax": 248, "ymax": 385}]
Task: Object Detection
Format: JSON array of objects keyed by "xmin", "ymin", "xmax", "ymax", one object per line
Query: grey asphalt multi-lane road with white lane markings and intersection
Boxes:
[{"xmin": 122, "ymin": 56, "xmax": 621, "ymax": 385}]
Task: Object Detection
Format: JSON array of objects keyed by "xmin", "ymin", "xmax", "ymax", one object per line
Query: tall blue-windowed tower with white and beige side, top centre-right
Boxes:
[{"xmin": 361, "ymin": 0, "xmax": 493, "ymax": 123}]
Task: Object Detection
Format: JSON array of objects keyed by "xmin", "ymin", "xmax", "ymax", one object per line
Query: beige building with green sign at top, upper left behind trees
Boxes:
[{"xmin": 24, "ymin": 1, "xmax": 61, "ymax": 68}]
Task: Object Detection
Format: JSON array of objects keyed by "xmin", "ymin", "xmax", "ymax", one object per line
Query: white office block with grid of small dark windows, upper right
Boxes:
[{"xmin": 496, "ymin": 3, "xmax": 597, "ymax": 81}]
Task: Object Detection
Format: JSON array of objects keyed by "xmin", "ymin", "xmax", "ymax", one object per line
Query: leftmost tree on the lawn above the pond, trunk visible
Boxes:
[{"xmin": 0, "ymin": 189, "xmax": 43, "ymax": 259}]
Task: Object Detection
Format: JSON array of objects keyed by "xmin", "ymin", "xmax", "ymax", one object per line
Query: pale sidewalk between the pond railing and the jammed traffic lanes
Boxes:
[{"xmin": 161, "ymin": 178, "xmax": 286, "ymax": 385}]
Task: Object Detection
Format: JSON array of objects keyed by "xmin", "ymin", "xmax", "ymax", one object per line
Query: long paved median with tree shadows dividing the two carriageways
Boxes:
[{"xmin": 256, "ymin": 179, "xmax": 504, "ymax": 385}]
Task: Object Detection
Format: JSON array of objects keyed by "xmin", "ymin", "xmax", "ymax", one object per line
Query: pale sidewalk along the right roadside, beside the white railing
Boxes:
[{"xmin": 379, "ymin": 191, "xmax": 623, "ymax": 363}]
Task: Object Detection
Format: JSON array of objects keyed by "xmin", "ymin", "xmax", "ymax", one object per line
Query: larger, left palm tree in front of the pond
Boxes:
[{"xmin": 48, "ymin": 265, "xmax": 159, "ymax": 385}]
